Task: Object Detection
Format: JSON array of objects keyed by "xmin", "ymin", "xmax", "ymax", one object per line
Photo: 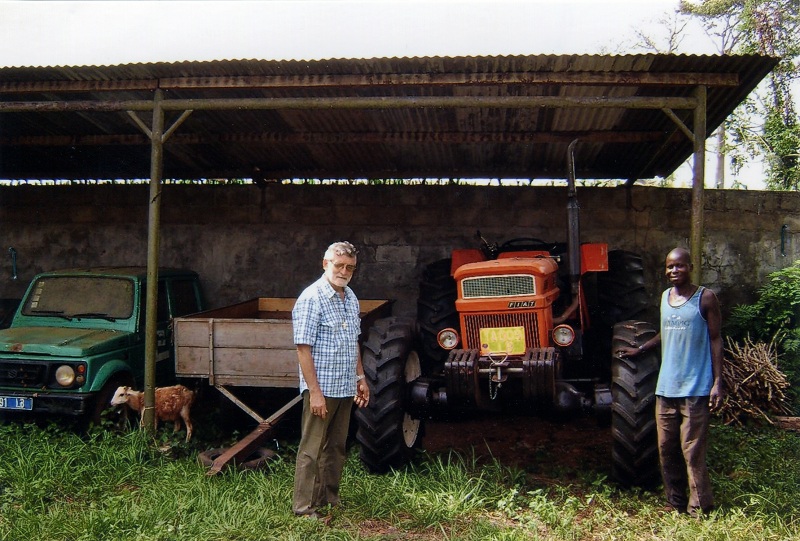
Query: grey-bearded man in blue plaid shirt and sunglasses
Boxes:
[{"xmin": 292, "ymin": 242, "xmax": 369, "ymax": 518}]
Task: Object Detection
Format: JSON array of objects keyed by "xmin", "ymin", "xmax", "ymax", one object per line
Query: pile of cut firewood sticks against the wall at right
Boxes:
[{"xmin": 717, "ymin": 338, "xmax": 792, "ymax": 425}]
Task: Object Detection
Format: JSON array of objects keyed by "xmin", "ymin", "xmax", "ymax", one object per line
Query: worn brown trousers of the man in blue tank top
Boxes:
[{"xmin": 656, "ymin": 396, "xmax": 714, "ymax": 515}]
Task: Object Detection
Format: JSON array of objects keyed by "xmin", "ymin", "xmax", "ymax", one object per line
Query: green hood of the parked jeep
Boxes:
[{"xmin": 0, "ymin": 327, "xmax": 131, "ymax": 357}]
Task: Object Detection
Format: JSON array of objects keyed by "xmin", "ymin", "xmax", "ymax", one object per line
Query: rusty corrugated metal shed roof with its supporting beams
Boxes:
[{"xmin": 0, "ymin": 54, "xmax": 776, "ymax": 179}]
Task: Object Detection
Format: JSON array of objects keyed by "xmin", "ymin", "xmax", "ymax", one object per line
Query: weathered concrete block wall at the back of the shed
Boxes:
[{"xmin": 0, "ymin": 184, "xmax": 800, "ymax": 315}]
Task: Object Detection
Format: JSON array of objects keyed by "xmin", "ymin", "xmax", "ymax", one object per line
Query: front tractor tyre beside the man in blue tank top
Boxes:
[{"xmin": 611, "ymin": 321, "xmax": 660, "ymax": 488}]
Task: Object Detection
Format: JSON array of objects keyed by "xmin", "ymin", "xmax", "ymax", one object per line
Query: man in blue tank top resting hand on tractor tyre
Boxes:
[{"xmin": 618, "ymin": 248, "xmax": 723, "ymax": 516}]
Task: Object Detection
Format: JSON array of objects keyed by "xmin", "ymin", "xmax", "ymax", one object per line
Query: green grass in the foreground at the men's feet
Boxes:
[{"xmin": 0, "ymin": 423, "xmax": 800, "ymax": 541}]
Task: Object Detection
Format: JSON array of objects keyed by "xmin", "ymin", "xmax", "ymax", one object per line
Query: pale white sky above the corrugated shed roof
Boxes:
[{"xmin": 0, "ymin": 0, "xmax": 715, "ymax": 66}]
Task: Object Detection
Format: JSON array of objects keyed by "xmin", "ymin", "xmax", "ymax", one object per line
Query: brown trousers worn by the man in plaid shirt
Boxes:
[{"xmin": 292, "ymin": 391, "xmax": 353, "ymax": 515}]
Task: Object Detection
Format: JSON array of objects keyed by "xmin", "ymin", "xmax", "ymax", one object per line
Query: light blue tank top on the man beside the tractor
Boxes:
[{"xmin": 656, "ymin": 286, "xmax": 714, "ymax": 398}]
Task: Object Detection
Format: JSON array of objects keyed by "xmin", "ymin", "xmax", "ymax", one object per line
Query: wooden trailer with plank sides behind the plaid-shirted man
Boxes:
[{"xmin": 173, "ymin": 297, "xmax": 392, "ymax": 475}]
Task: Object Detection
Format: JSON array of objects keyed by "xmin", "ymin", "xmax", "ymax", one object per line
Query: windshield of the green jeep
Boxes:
[{"xmin": 22, "ymin": 276, "xmax": 134, "ymax": 321}]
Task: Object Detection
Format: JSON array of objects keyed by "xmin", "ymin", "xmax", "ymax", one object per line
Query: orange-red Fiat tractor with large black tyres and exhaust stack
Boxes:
[{"xmin": 356, "ymin": 145, "xmax": 659, "ymax": 486}]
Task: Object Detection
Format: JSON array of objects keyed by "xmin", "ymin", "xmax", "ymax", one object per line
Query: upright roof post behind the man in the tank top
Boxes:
[{"xmin": 690, "ymin": 86, "xmax": 708, "ymax": 284}]
